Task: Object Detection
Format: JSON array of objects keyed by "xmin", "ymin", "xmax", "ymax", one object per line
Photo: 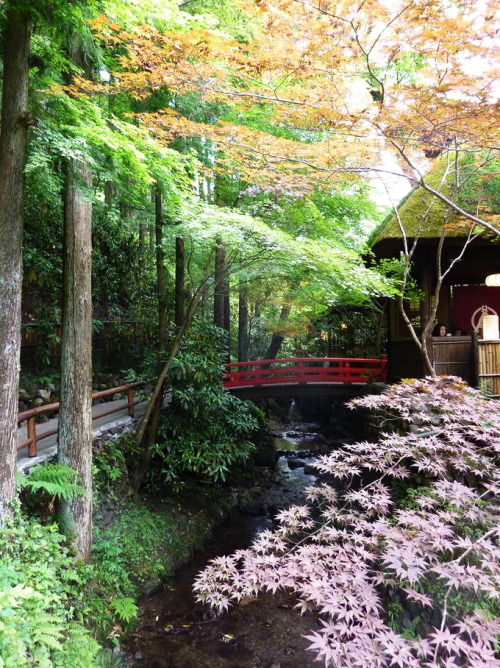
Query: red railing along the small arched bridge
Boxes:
[{"xmin": 224, "ymin": 356, "xmax": 387, "ymax": 389}]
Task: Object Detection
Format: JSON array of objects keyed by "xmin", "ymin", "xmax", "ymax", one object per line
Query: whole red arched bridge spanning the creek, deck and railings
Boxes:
[{"xmin": 224, "ymin": 356, "xmax": 387, "ymax": 399}]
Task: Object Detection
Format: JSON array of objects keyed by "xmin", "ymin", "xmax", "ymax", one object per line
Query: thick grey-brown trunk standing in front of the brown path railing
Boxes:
[{"xmin": 58, "ymin": 160, "xmax": 92, "ymax": 562}]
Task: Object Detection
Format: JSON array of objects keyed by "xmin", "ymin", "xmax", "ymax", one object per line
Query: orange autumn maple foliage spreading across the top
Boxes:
[{"xmin": 80, "ymin": 0, "xmax": 499, "ymax": 232}]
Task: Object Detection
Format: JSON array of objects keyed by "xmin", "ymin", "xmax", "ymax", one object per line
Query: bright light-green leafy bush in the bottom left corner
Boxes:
[{"xmin": 0, "ymin": 516, "xmax": 100, "ymax": 668}]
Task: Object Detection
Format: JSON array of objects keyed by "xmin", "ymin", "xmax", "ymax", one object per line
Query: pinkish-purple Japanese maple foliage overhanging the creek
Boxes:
[{"xmin": 194, "ymin": 377, "xmax": 500, "ymax": 668}]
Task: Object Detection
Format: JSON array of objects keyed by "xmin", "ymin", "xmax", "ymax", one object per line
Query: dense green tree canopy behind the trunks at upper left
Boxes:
[{"xmin": 11, "ymin": 0, "xmax": 389, "ymax": 372}]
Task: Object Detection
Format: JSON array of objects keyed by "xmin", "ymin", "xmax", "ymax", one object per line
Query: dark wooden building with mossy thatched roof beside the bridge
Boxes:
[{"xmin": 371, "ymin": 160, "xmax": 500, "ymax": 395}]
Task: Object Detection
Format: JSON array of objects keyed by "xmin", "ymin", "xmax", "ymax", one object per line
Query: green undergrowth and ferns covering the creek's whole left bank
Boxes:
[{"xmin": 0, "ymin": 437, "xmax": 230, "ymax": 668}]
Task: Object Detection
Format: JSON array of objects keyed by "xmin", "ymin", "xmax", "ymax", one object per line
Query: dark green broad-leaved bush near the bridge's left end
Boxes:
[{"xmin": 152, "ymin": 326, "xmax": 258, "ymax": 487}]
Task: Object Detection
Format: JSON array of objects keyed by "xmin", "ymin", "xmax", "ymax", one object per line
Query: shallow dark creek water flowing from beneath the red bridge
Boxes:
[{"xmin": 127, "ymin": 425, "xmax": 326, "ymax": 668}]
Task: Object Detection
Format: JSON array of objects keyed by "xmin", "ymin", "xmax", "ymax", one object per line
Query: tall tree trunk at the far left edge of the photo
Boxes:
[{"xmin": 0, "ymin": 9, "xmax": 31, "ymax": 521}]
